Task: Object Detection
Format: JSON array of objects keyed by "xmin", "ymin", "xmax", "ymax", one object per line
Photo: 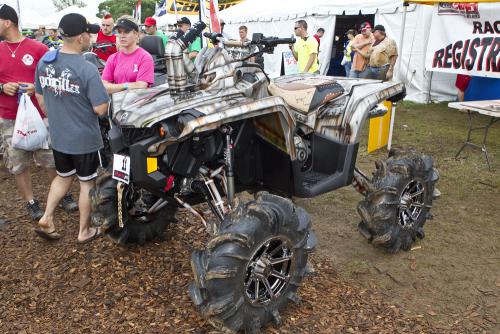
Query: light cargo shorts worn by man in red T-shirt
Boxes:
[{"xmin": 0, "ymin": 118, "xmax": 55, "ymax": 175}]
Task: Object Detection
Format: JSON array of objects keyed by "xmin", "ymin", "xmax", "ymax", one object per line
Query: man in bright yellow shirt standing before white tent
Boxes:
[{"xmin": 290, "ymin": 20, "xmax": 319, "ymax": 73}]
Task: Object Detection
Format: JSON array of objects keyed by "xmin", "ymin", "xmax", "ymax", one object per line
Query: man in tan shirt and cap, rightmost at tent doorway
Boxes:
[{"xmin": 358, "ymin": 24, "xmax": 398, "ymax": 81}]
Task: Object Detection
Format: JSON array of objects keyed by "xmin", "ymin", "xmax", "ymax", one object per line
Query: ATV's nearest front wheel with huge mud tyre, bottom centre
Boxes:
[{"xmin": 189, "ymin": 193, "xmax": 316, "ymax": 333}]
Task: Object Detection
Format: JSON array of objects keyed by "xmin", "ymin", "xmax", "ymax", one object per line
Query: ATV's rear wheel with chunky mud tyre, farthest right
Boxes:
[{"xmin": 358, "ymin": 150, "xmax": 439, "ymax": 252}]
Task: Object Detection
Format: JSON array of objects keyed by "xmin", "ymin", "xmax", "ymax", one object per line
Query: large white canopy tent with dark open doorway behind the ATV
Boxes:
[{"xmin": 220, "ymin": 0, "xmax": 456, "ymax": 102}]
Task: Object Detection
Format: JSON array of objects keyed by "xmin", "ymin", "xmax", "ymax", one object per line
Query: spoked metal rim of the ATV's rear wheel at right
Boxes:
[{"xmin": 398, "ymin": 180, "xmax": 425, "ymax": 228}]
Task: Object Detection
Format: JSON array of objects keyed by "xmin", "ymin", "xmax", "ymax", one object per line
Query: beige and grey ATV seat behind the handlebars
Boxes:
[{"xmin": 269, "ymin": 74, "xmax": 344, "ymax": 113}]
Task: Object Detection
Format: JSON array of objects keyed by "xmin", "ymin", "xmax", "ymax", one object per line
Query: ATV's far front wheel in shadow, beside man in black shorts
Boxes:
[{"xmin": 90, "ymin": 171, "xmax": 177, "ymax": 245}]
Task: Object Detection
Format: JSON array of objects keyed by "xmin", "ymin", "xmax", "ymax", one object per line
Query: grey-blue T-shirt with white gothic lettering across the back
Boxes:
[{"xmin": 35, "ymin": 52, "xmax": 109, "ymax": 154}]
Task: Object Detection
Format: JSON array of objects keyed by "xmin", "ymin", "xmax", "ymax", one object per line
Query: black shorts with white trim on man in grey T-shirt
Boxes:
[{"xmin": 52, "ymin": 150, "xmax": 102, "ymax": 181}]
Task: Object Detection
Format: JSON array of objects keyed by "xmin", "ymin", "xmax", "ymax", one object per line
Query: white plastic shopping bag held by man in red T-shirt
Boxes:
[{"xmin": 12, "ymin": 94, "xmax": 49, "ymax": 151}]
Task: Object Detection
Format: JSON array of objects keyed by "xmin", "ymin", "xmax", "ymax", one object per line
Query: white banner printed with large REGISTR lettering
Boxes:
[{"xmin": 425, "ymin": 3, "xmax": 500, "ymax": 78}]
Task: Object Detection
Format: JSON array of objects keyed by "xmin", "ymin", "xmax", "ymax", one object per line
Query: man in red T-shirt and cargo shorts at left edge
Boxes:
[{"xmin": 0, "ymin": 4, "xmax": 78, "ymax": 220}]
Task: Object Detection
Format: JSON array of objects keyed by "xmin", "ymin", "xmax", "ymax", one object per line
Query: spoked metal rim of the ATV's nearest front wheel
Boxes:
[{"xmin": 244, "ymin": 237, "xmax": 295, "ymax": 306}]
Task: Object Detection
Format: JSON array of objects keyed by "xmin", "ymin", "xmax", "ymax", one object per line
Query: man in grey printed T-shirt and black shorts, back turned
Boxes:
[{"xmin": 35, "ymin": 13, "xmax": 109, "ymax": 243}]
